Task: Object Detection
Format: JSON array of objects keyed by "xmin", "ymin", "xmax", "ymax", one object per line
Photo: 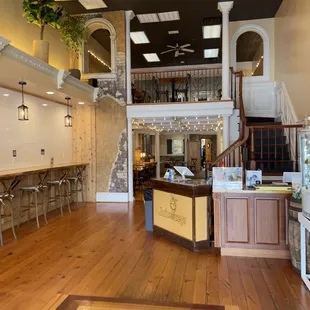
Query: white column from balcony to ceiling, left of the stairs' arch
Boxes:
[{"xmin": 218, "ymin": 1, "xmax": 234, "ymax": 100}]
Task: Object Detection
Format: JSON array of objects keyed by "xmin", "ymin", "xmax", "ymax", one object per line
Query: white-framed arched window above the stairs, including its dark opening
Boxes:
[{"xmin": 231, "ymin": 24, "xmax": 270, "ymax": 81}]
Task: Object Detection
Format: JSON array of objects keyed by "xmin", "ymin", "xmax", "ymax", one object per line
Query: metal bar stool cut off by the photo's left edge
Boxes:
[{"xmin": 0, "ymin": 176, "xmax": 21, "ymax": 246}]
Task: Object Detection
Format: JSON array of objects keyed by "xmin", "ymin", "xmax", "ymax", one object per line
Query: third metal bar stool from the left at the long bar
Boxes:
[{"xmin": 47, "ymin": 170, "xmax": 71, "ymax": 216}]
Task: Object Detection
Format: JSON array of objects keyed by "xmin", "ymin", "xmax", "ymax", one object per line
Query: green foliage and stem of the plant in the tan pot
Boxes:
[{"xmin": 23, "ymin": 0, "xmax": 63, "ymax": 40}]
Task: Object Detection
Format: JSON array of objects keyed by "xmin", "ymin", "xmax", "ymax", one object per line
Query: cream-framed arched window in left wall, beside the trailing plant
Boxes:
[{"xmin": 80, "ymin": 18, "xmax": 116, "ymax": 79}]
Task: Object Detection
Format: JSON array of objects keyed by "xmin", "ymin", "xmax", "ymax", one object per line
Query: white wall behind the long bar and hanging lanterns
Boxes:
[{"xmin": 0, "ymin": 88, "xmax": 72, "ymax": 170}]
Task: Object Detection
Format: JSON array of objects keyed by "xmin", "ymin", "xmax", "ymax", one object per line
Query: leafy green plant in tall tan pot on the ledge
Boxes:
[{"xmin": 23, "ymin": 0, "xmax": 62, "ymax": 63}]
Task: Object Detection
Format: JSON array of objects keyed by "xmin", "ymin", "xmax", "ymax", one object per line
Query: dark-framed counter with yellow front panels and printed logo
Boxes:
[{"xmin": 152, "ymin": 179, "xmax": 212, "ymax": 251}]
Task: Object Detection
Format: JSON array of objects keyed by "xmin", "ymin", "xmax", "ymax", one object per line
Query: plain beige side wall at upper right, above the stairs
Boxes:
[{"xmin": 275, "ymin": 0, "xmax": 310, "ymax": 119}]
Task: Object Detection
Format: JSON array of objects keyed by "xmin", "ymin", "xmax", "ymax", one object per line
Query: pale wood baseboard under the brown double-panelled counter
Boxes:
[{"xmin": 221, "ymin": 248, "xmax": 291, "ymax": 259}]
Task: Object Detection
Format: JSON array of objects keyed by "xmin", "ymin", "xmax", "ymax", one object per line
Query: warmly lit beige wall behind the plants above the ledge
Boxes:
[{"xmin": 0, "ymin": 0, "xmax": 69, "ymax": 69}]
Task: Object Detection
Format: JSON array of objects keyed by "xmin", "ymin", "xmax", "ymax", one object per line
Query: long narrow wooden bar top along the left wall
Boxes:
[{"xmin": 0, "ymin": 162, "xmax": 88, "ymax": 178}]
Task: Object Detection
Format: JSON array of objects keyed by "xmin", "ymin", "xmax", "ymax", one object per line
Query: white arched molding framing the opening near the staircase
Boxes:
[{"xmin": 231, "ymin": 24, "xmax": 270, "ymax": 82}]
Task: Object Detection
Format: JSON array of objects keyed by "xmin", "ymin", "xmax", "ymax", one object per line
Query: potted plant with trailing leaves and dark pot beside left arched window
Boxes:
[{"xmin": 60, "ymin": 14, "xmax": 86, "ymax": 79}]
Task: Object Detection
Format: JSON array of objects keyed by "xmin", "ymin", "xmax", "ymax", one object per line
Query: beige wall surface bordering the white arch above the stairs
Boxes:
[{"xmin": 230, "ymin": 17, "xmax": 274, "ymax": 80}]
